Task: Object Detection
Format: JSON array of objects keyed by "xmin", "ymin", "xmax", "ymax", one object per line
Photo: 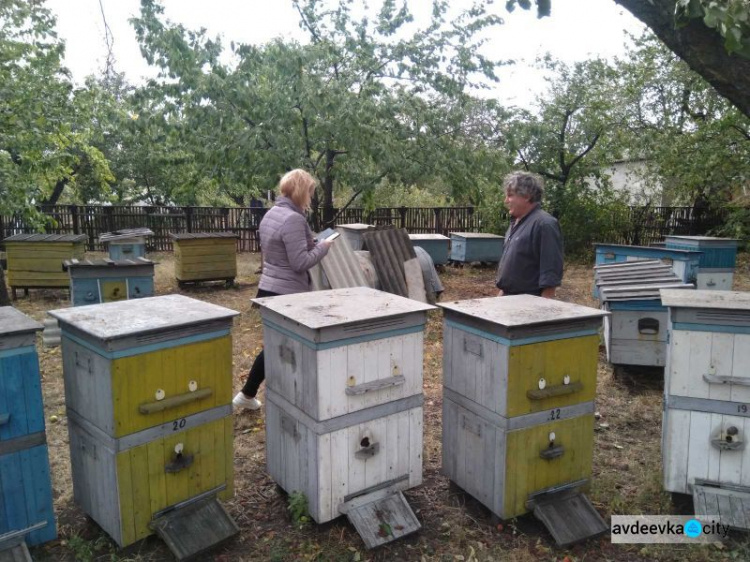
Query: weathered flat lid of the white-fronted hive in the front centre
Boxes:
[{"xmin": 253, "ymin": 287, "xmax": 435, "ymax": 330}]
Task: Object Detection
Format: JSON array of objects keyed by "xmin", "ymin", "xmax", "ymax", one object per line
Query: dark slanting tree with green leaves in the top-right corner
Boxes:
[{"xmin": 507, "ymin": 0, "xmax": 750, "ymax": 117}]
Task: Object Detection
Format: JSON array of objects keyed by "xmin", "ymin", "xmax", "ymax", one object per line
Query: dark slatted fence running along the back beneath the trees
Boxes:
[{"xmin": 0, "ymin": 205, "xmax": 724, "ymax": 253}]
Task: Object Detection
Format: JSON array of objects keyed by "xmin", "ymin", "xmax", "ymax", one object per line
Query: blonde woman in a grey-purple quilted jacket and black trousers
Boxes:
[{"xmin": 232, "ymin": 169, "xmax": 331, "ymax": 410}]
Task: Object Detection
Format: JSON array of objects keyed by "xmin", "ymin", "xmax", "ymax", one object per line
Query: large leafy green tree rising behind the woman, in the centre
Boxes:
[{"xmin": 134, "ymin": 0, "xmax": 508, "ymax": 221}]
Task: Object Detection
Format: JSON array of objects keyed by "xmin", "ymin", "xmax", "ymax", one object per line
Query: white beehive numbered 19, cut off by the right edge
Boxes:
[{"xmin": 661, "ymin": 290, "xmax": 750, "ymax": 529}]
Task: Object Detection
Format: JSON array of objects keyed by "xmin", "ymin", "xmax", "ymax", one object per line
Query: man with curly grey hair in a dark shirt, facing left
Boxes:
[{"xmin": 495, "ymin": 172, "xmax": 563, "ymax": 298}]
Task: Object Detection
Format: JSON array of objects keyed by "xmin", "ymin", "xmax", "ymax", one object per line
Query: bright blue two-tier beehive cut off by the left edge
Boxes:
[{"xmin": 0, "ymin": 306, "xmax": 57, "ymax": 546}]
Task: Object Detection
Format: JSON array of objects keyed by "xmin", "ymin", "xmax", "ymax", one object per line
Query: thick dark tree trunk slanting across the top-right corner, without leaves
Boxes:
[{"xmin": 615, "ymin": 0, "xmax": 750, "ymax": 117}]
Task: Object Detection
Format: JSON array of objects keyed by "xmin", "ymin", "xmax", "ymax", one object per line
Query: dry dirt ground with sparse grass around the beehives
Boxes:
[{"xmin": 10, "ymin": 254, "xmax": 750, "ymax": 562}]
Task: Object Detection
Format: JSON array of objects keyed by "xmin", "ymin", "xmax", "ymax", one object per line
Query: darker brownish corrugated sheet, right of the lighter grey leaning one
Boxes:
[{"xmin": 362, "ymin": 228, "xmax": 417, "ymax": 297}]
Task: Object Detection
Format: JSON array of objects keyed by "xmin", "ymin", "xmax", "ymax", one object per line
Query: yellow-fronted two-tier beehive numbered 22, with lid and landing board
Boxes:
[{"xmin": 440, "ymin": 295, "xmax": 608, "ymax": 545}]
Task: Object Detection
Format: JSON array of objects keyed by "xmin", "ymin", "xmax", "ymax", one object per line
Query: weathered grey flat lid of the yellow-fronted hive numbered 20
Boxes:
[{"xmin": 49, "ymin": 295, "xmax": 239, "ymax": 340}]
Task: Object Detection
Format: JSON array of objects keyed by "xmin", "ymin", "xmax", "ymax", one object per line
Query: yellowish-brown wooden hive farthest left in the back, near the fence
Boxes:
[{"xmin": 4, "ymin": 234, "xmax": 86, "ymax": 298}]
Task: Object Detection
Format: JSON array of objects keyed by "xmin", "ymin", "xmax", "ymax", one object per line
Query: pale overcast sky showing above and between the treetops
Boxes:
[{"xmin": 47, "ymin": 0, "xmax": 644, "ymax": 107}]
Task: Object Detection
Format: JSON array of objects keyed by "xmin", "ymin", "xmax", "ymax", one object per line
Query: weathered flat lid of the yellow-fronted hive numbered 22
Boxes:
[{"xmin": 438, "ymin": 295, "xmax": 609, "ymax": 328}]
